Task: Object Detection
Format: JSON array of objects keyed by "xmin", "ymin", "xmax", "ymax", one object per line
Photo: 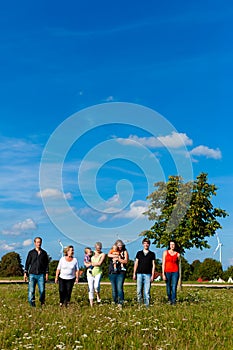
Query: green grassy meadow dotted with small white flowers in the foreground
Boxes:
[{"xmin": 0, "ymin": 284, "xmax": 233, "ymax": 350}]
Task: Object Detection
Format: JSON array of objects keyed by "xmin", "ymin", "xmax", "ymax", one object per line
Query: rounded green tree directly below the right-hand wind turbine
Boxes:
[{"xmin": 198, "ymin": 258, "xmax": 223, "ymax": 281}]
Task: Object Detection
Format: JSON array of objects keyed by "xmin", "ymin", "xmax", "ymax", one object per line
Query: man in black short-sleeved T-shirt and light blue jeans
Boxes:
[{"xmin": 133, "ymin": 238, "xmax": 155, "ymax": 307}]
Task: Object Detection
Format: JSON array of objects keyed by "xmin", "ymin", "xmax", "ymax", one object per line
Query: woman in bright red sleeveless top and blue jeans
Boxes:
[{"xmin": 162, "ymin": 241, "xmax": 180, "ymax": 305}]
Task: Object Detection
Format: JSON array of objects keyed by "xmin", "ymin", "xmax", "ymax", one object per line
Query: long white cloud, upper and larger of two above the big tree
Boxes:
[{"xmin": 116, "ymin": 131, "xmax": 193, "ymax": 148}]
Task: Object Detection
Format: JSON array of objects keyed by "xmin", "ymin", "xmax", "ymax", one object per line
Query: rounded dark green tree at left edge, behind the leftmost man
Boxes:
[{"xmin": 0, "ymin": 252, "xmax": 23, "ymax": 277}]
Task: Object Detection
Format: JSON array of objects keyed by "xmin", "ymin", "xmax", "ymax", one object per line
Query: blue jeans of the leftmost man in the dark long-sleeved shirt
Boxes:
[{"xmin": 28, "ymin": 274, "xmax": 45, "ymax": 306}]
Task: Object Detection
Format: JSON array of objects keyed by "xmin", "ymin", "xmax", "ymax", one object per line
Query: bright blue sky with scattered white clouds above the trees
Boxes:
[{"xmin": 0, "ymin": 1, "xmax": 233, "ymax": 268}]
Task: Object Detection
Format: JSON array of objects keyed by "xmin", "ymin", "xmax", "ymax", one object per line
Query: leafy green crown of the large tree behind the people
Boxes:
[{"xmin": 141, "ymin": 173, "xmax": 228, "ymax": 253}]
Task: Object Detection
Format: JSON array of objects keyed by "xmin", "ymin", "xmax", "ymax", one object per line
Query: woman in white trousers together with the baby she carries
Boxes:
[{"xmin": 84, "ymin": 242, "xmax": 105, "ymax": 306}]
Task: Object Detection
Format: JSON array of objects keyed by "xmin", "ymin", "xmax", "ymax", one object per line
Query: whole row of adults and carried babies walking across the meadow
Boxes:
[{"xmin": 24, "ymin": 237, "xmax": 180, "ymax": 308}]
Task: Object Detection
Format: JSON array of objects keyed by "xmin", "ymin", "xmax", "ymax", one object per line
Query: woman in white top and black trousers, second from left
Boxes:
[{"xmin": 55, "ymin": 245, "xmax": 79, "ymax": 306}]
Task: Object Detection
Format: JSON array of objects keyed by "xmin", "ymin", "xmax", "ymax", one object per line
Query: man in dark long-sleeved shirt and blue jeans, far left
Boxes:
[{"xmin": 24, "ymin": 237, "xmax": 49, "ymax": 306}]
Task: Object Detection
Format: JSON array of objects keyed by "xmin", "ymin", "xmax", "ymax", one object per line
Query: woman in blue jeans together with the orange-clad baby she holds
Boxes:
[{"xmin": 108, "ymin": 239, "xmax": 129, "ymax": 307}]
